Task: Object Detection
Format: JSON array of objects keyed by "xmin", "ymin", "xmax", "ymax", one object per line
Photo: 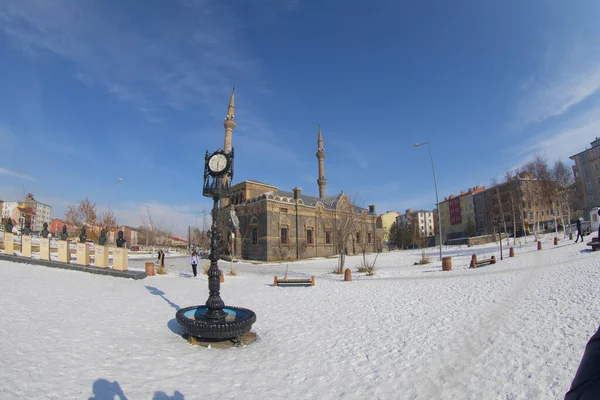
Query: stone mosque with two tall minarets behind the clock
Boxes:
[{"xmin": 219, "ymin": 91, "xmax": 384, "ymax": 261}]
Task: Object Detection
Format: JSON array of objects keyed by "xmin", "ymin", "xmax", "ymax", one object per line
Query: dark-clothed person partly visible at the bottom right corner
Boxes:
[{"xmin": 565, "ymin": 327, "xmax": 600, "ymax": 400}]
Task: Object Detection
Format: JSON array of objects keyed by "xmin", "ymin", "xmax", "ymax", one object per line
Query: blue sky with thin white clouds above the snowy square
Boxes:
[{"xmin": 0, "ymin": 0, "xmax": 600, "ymax": 233}]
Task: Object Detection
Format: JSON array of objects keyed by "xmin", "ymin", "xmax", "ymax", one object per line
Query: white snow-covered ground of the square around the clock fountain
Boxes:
[{"xmin": 0, "ymin": 235, "xmax": 600, "ymax": 399}]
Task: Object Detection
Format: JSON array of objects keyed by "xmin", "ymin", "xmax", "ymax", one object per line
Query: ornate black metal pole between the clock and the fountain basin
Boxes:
[{"xmin": 206, "ymin": 197, "xmax": 227, "ymax": 320}]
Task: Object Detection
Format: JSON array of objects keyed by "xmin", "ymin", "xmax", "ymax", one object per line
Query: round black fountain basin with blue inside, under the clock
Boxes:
[{"xmin": 175, "ymin": 305, "xmax": 256, "ymax": 339}]
